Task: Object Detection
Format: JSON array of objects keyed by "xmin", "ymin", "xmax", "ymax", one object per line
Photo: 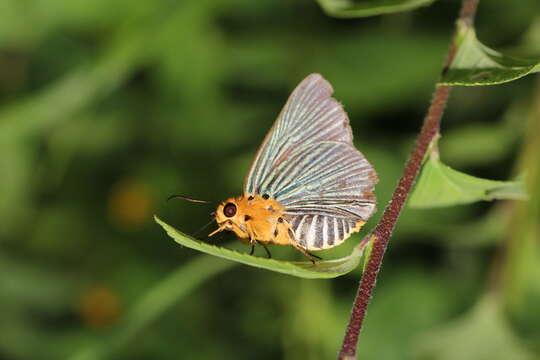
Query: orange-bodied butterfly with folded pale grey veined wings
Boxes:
[{"xmin": 208, "ymin": 74, "xmax": 378, "ymax": 262}]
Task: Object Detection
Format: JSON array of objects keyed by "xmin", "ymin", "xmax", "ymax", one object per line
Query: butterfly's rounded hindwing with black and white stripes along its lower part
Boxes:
[{"xmin": 265, "ymin": 141, "xmax": 377, "ymax": 250}]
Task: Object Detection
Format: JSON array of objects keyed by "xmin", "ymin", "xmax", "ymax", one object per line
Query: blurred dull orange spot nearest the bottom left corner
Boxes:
[{"xmin": 79, "ymin": 286, "xmax": 120, "ymax": 328}]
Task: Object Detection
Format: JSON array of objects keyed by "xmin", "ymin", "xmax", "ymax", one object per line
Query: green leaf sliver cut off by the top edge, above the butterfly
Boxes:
[{"xmin": 317, "ymin": 0, "xmax": 435, "ymax": 18}]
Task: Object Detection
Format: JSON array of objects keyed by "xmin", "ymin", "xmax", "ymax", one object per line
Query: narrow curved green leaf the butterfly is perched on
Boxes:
[{"xmin": 154, "ymin": 216, "xmax": 363, "ymax": 279}]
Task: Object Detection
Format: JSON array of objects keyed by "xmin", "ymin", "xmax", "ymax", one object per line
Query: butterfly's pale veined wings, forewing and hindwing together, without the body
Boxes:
[{"xmin": 244, "ymin": 74, "xmax": 377, "ymax": 250}]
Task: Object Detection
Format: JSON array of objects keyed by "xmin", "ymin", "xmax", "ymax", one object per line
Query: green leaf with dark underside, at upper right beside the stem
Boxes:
[{"xmin": 439, "ymin": 21, "xmax": 540, "ymax": 86}]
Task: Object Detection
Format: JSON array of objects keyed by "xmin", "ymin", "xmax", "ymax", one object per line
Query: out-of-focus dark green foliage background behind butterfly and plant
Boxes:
[{"xmin": 0, "ymin": 0, "xmax": 540, "ymax": 360}]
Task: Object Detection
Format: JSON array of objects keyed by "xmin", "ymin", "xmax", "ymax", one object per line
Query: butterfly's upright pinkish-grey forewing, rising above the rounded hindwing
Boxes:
[{"xmin": 244, "ymin": 74, "xmax": 352, "ymax": 194}]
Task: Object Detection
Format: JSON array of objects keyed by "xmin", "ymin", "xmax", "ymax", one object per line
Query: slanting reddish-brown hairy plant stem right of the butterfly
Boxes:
[{"xmin": 338, "ymin": 0, "xmax": 479, "ymax": 360}]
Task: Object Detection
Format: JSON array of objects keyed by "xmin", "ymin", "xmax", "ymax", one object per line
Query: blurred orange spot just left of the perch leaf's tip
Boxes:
[{"xmin": 109, "ymin": 180, "xmax": 153, "ymax": 229}]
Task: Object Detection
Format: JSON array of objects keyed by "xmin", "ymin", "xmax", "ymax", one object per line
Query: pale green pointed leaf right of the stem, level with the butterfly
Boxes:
[{"xmin": 409, "ymin": 150, "xmax": 527, "ymax": 208}]
